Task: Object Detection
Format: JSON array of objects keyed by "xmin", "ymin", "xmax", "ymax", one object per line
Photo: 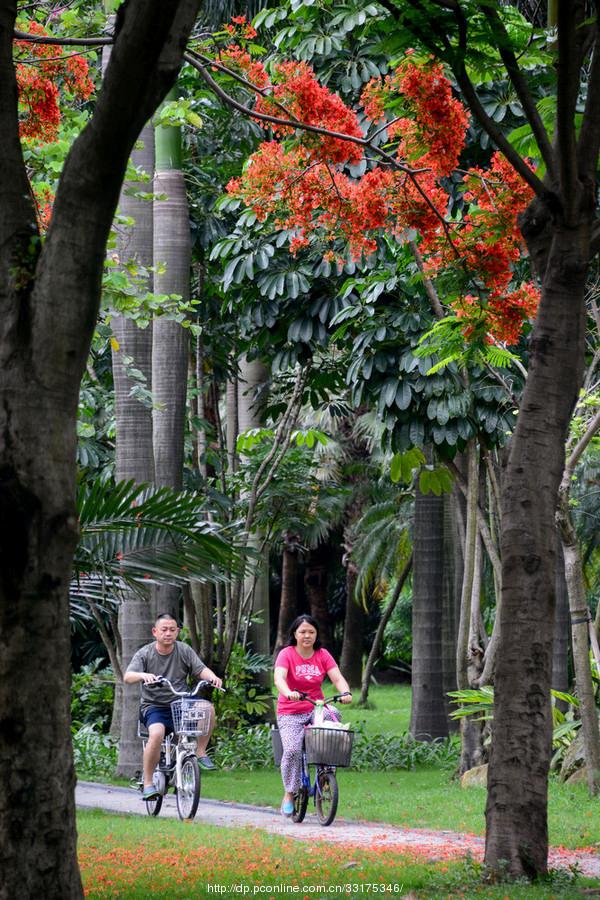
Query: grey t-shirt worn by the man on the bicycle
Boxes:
[{"xmin": 127, "ymin": 641, "xmax": 204, "ymax": 713}]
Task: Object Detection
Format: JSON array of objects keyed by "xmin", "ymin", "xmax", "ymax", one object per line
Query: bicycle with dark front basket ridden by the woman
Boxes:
[{"xmin": 273, "ymin": 691, "xmax": 354, "ymax": 826}]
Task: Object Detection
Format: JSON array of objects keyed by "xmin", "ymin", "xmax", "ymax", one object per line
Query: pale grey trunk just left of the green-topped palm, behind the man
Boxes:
[{"xmin": 111, "ymin": 118, "xmax": 154, "ymax": 778}]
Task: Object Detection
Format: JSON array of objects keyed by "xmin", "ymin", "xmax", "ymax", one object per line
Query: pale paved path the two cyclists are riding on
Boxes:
[{"xmin": 75, "ymin": 781, "xmax": 600, "ymax": 878}]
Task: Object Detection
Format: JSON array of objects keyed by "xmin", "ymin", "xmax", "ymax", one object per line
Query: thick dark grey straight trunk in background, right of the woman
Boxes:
[{"xmin": 410, "ymin": 487, "xmax": 448, "ymax": 741}]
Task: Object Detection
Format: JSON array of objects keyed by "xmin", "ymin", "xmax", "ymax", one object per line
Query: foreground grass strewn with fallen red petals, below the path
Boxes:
[{"xmin": 78, "ymin": 811, "xmax": 600, "ymax": 900}]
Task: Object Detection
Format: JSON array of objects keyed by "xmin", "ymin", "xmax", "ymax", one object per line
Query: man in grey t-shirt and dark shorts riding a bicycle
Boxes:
[{"xmin": 123, "ymin": 613, "xmax": 222, "ymax": 800}]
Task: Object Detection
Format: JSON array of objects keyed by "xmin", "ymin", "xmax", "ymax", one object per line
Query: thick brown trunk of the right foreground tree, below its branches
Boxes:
[{"xmin": 486, "ymin": 220, "xmax": 589, "ymax": 877}]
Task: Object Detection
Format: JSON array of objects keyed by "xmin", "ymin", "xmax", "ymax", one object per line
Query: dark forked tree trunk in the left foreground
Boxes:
[{"xmin": 0, "ymin": 0, "xmax": 199, "ymax": 900}]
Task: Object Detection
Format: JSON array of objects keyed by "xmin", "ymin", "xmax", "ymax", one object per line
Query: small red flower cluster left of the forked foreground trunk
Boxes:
[{"xmin": 14, "ymin": 21, "xmax": 94, "ymax": 143}]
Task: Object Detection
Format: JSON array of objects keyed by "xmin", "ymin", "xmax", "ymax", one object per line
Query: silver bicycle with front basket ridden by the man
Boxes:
[{"xmin": 138, "ymin": 677, "xmax": 223, "ymax": 820}]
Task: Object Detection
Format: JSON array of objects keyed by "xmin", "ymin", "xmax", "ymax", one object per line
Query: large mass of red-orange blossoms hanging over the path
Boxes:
[{"xmin": 227, "ymin": 47, "xmax": 539, "ymax": 344}]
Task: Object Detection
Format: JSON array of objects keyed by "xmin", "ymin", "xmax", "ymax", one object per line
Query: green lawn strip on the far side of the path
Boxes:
[{"xmin": 202, "ymin": 767, "xmax": 600, "ymax": 848}]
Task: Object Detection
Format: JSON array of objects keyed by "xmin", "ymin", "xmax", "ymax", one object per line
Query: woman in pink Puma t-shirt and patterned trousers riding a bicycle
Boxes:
[{"xmin": 274, "ymin": 615, "xmax": 352, "ymax": 816}]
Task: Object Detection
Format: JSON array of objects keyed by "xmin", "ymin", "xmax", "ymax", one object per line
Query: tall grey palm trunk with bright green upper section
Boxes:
[{"xmin": 152, "ymin": 92, "xmax": 191, "ymax": 620}]
